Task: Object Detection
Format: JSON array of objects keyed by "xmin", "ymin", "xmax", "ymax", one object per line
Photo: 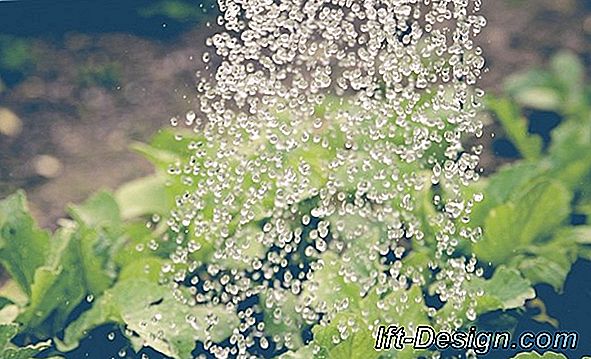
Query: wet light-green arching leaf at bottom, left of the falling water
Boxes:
[{"xmin": 58, "ymin": 278, "xmax": 238, "ymax": 358}]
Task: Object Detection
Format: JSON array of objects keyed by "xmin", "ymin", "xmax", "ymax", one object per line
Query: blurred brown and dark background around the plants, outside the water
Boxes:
[{"xmin": 0, "ymin": 0, "xmax": 591, "ymax": 358}]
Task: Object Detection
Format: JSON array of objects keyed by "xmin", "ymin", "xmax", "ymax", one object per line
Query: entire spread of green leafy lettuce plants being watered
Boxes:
[{"xmin": 0, "ymin": 29, "xmax": 591, "ymax": 359}]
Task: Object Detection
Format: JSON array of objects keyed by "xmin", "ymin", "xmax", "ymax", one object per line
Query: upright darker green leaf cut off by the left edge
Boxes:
[{"xmin": 0, "ymin": 191, "xmax": 49, "ymax": 295}]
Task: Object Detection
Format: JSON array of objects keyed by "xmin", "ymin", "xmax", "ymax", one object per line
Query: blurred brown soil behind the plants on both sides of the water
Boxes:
[{"xmin": 0, "ymin": 0, "xmax": 591, "ymax": 228}]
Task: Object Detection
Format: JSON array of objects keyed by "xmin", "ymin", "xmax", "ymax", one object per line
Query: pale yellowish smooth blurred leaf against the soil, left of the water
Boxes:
[{"xmin": 115, "ymin": 175, "xmax": 174, "ymax": 219}]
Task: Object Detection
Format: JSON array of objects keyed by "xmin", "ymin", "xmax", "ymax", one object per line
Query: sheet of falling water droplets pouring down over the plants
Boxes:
[{"xmin": 165, "ymin": 0, "xmax": 486, "ymax": 357}]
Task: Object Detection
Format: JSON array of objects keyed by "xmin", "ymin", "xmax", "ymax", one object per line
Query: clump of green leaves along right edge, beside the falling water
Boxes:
[{"xmin": 472, "ymin": 53, "xmax": 591, "ymax": 291}]
